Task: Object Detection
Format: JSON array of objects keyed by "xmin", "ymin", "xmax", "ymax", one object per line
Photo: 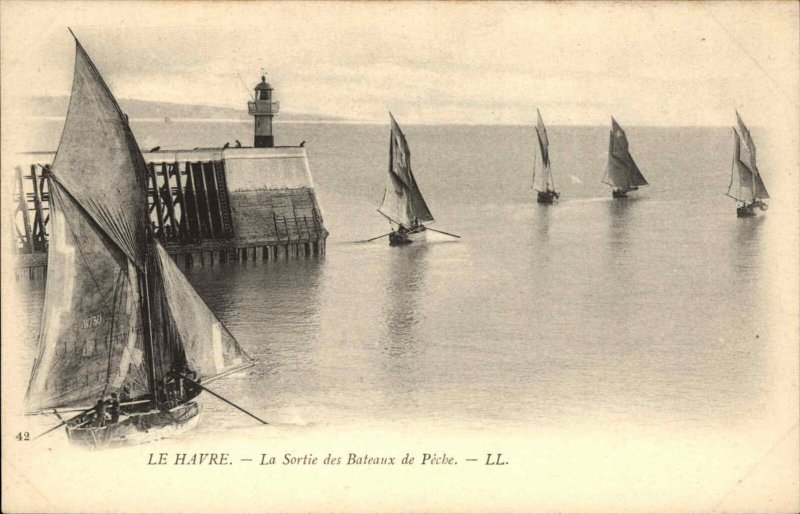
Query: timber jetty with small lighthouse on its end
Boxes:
[{"xmin": 12, "ymin": 77, "xmax": 328, "ymax": 278}]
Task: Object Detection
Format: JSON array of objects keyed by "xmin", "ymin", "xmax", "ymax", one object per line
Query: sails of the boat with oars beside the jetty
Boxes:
[{"xmin": 378, "ymin": 113, "xmax": 433, "ymax": 227}]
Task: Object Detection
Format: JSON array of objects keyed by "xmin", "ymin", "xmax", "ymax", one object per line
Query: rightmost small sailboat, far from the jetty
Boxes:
[{"xmin": 726, "ymin": 112, "xmax": 769, "ymax": 218}]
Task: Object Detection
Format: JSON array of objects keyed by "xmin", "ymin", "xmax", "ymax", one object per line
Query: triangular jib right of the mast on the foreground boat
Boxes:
[{"xmin": 153, "ymin": 243, "xmax": 253, "ymax": 382}]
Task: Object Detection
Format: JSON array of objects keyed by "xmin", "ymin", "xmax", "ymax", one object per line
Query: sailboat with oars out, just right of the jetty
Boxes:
[{"xmin": 378, "ymin": 113, "xmax": 433, "ymax": 246}]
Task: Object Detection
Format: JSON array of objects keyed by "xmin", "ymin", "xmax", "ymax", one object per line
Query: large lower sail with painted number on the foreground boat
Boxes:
[{"xmin": 26, "ymin": 179, "xmax": 149, "ymax": 412}]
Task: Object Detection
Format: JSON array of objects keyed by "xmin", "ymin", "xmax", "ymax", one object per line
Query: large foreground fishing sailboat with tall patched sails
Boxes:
[{"xmin": 26, "ymin": 38, "xmax": 253, "ymax": 449}]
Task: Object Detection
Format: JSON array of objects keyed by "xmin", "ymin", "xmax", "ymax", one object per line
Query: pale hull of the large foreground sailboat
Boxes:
[{"xmin": 67, "ymin": 400, "xmax": 201, "ymax": 450}]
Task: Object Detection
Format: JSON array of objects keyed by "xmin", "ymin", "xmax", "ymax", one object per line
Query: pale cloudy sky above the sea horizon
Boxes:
[{"xmin": 0, "ymin": 1, "xmax": 800, "ymax": 125}]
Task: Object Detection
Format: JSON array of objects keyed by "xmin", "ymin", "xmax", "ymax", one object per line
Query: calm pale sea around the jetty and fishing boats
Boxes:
[{"xmin": 12, "ymin": 118, "xmax": 773, "ymax": 433}]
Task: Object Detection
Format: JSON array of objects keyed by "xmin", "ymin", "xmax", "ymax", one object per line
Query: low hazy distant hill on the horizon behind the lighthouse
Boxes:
[{"xmin": 22, "ymin": 96, "xmax": 344, "ymax": 121}]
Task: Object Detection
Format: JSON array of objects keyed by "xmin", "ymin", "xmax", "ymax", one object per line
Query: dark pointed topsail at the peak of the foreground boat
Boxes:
[{"xmin": 52, "ymin": 40, "xmax": 149, "ymax": 268}]
